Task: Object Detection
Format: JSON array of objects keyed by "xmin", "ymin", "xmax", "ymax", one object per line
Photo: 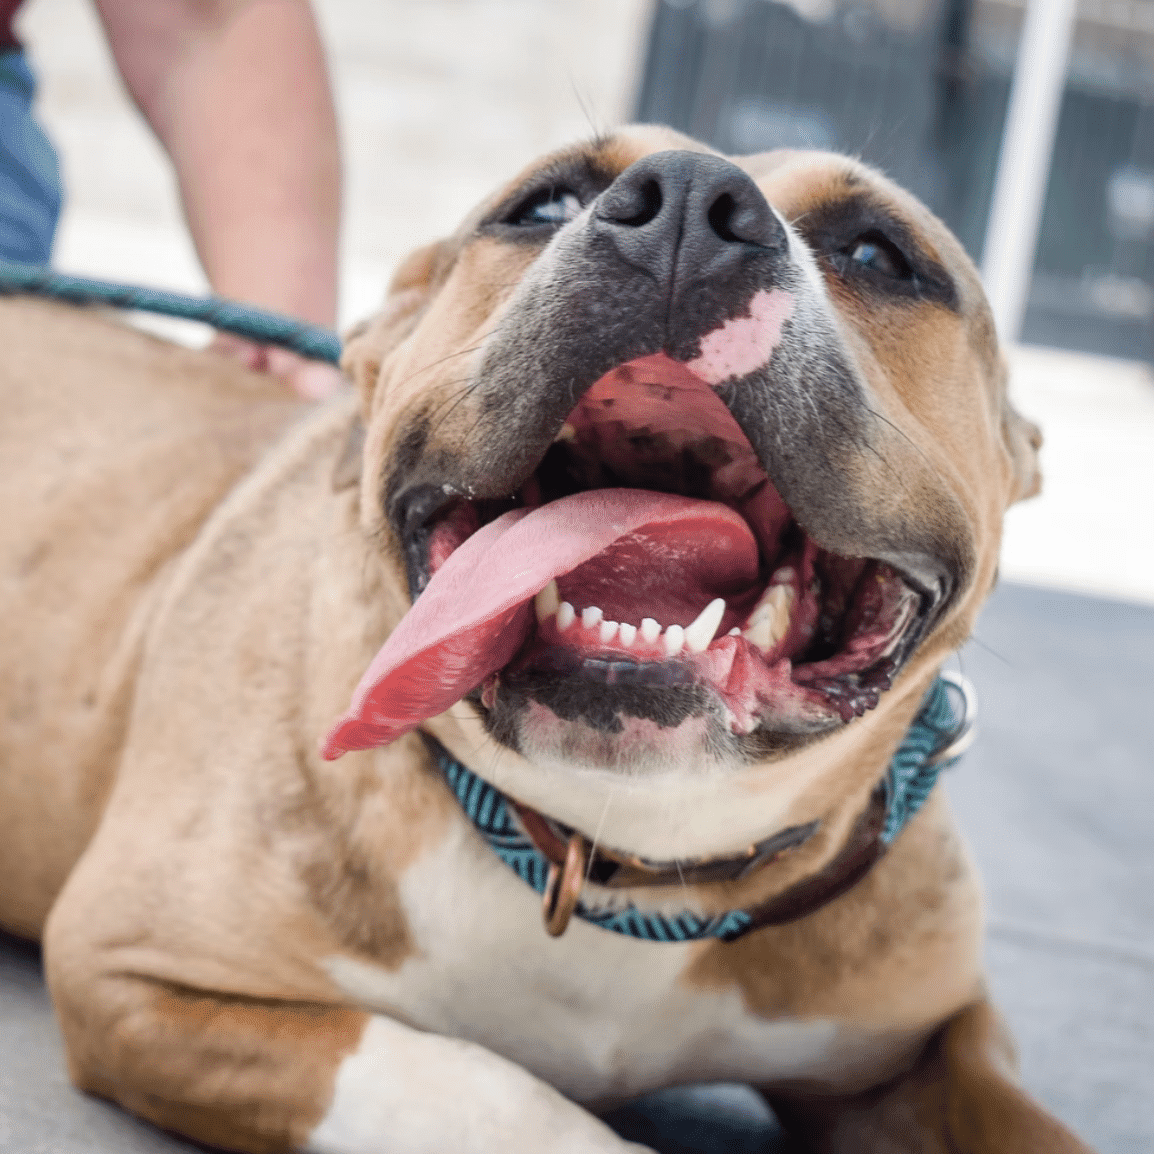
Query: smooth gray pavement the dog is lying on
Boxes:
[{"xmin": 0, "ymin": 585, "xmax": 1154, "ymax": 1154}]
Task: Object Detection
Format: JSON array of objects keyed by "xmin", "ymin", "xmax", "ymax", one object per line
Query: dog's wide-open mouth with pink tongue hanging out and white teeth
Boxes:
[{"xmin": 320, "ymin": 354, "xmax": 932, "ymax": 748}]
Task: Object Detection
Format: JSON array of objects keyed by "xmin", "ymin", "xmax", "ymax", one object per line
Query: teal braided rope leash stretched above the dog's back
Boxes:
[{"xmin": 0, "ymin": 261, "xmax": 340, "ymax": 365}]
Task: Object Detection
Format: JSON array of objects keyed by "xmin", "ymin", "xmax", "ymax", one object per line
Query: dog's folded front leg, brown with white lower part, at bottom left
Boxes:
[{"xmin": 53, "ymin": 977, "xmax": 642, "ymax": 1154}]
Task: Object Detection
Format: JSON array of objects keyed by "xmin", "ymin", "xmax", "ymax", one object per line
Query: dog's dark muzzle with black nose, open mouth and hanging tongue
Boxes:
[{"xmin": 328, "ymin": 152, "xmax": 943, "ymax": 764}]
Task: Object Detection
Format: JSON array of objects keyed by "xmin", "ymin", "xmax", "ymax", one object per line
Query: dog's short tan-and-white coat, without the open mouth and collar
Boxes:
[{"xmin": 0, "ymin": 128, "xmax": 1086, "ymax": 1154}]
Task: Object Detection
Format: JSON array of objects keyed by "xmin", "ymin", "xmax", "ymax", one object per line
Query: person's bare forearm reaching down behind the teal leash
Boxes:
[{"xmin": 98, "ymin": 0, "xmax": 340, "ymax": 324}]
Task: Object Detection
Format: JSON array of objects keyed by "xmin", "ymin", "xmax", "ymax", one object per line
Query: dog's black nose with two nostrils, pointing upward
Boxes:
[{"xmin": 593, "ymin": 151, "xmax": 787, "ymax": 279}]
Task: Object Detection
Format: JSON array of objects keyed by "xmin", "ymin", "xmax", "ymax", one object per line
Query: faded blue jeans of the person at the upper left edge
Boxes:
[{"xmin": 0, "ymin": 48, "xmax": 63, "ymax": 264}]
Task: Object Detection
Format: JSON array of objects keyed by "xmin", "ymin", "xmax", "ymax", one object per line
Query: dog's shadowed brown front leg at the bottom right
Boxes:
[{"xmin": 764, "ymin": 1002, "xmax": 1093, "ymax": 1154}]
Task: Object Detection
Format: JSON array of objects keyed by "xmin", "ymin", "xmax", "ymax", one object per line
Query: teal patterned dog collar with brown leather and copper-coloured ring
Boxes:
[{"xmin": 429, "ymin": 672, "xmax": 977, "ymax": 942}]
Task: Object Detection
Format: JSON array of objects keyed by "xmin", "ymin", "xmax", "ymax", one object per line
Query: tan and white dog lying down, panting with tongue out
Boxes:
[{"xmin": 0, "ymin": 127, "xmax": 1087, "ymax": 1154}]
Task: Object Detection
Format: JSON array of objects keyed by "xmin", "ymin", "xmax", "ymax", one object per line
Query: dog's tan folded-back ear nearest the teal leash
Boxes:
[{"xmin": 340, "ymin": 240, "xmax": 457, "ymax": 417}]
